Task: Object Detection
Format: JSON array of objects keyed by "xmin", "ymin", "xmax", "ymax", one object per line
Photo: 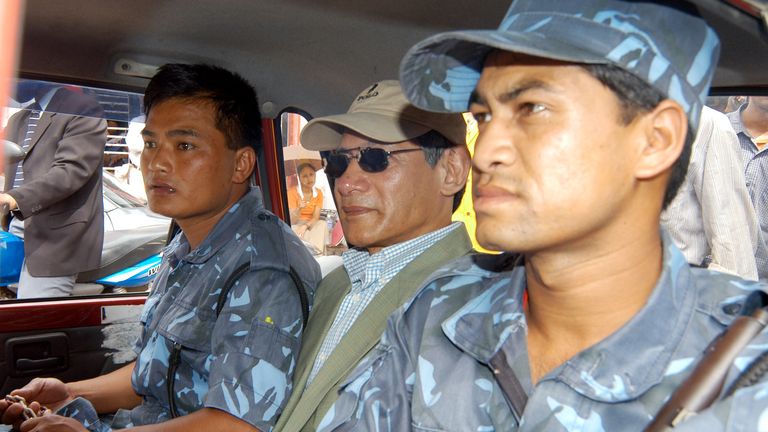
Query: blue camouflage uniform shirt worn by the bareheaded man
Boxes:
[{"xmin": 60, "ymin": 189, "xmax": 320, "ymax": 431}]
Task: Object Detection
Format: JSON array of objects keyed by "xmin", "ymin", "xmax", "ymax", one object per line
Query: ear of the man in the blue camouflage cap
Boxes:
[{"xmin": 635, "ymin": 99, "xmax": 688, "ymax": 180}]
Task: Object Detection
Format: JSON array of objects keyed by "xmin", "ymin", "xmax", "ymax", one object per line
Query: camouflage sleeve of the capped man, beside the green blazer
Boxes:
[{"xmin": 318, "ymin": 289, "xmax": 434, "ymax": 432}]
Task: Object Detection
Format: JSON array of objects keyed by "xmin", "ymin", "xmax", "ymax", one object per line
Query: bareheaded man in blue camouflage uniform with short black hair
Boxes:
[{"xmin": 0, "ymin": 64, "xmax": 320, "ymax": 432}]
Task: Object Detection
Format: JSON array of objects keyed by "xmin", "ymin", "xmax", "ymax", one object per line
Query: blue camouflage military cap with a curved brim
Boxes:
[{"xmin": 400, "ymin": 0, "xmax": 720, "ymax": 128}]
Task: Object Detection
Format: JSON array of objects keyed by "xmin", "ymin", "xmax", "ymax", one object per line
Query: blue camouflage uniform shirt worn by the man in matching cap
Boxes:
[{"xmin": 319, "ymin": 236, "xmax": 768, "ymax": 432}]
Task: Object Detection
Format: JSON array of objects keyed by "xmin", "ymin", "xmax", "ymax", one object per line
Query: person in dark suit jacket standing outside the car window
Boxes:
[{"xmin": 0, "ymin": 87, "xmax": 107, "ymax": 298}]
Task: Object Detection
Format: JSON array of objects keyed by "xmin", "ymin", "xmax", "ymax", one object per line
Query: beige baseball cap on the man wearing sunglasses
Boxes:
[{"xmin": 301, "ymin": 80, "xmax": 467, "ymax": 150}]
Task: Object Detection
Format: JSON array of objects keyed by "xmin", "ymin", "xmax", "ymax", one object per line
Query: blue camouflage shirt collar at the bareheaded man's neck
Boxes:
[{"xmin": 166, "ymin": 187, "xmax": 264, "ymax": 267}]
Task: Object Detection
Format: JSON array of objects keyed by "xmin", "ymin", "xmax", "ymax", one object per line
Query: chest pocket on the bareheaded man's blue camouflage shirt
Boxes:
[{"xmin": 155, "ymin": 300, "xmax": 216, "ymax": 352}]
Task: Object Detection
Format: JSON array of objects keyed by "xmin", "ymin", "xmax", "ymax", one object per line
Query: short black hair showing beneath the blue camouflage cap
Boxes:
[{"xmin": 582, "ymin": 64, "xmax": 696, "ymax": 209}]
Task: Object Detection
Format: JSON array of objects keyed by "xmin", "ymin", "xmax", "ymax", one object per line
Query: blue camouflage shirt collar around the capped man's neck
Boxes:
[{"xmin": 443, "ymin": 234, "xmax": 697, "ymax": 402}]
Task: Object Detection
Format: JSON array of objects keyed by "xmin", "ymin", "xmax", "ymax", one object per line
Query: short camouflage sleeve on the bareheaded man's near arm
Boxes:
[{"xmin": 202, "ymin": 269, "xmax": 302, "ymax": 431}]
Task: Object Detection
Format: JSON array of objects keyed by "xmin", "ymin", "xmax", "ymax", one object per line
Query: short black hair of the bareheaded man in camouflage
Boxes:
[{"xmin": 144, "ymin": 63, "xmax": 262, "ymax": 153}]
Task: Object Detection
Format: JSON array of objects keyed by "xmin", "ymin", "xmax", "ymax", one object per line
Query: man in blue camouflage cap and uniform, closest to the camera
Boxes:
[{"xmin": 320, "ymin": 0, "xmax": 768, "ymax": 431}]
